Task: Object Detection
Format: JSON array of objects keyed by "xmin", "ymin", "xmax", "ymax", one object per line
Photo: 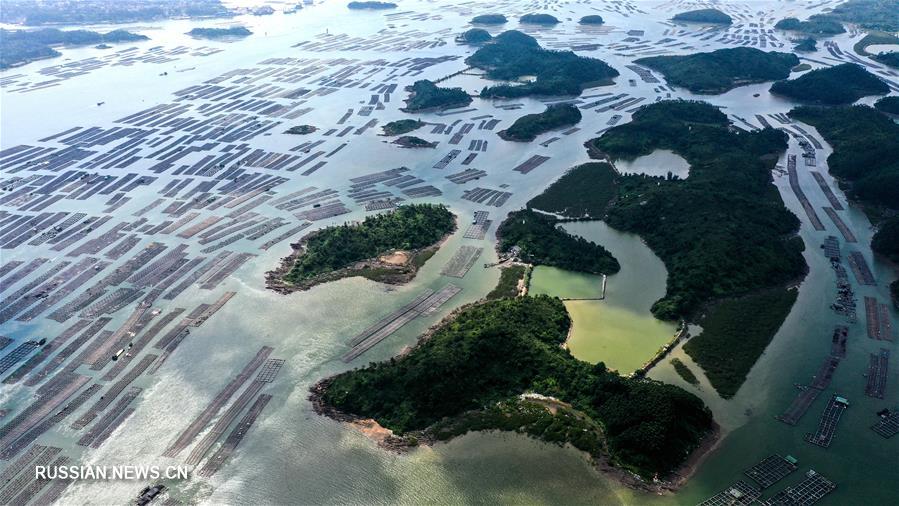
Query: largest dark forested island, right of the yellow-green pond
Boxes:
[{"xmin": 588, "ymin": 100, "xmax": 807, "ymax": 397}]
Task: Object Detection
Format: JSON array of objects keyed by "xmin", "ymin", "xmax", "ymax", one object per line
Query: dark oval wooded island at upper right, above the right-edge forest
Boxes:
[{"xmin": 771, "ymin": 63, "xmax": 890, "ymax": 105}]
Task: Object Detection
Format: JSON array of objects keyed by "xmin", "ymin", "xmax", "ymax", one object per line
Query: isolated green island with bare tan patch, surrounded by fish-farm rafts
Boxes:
[{"xmin": 266, "ymin": 204, "xmax": 456, "ymax": 293}]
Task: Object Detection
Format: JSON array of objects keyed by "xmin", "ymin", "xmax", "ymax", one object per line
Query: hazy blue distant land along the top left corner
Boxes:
[{"xmin": 0, "ymin": 0, "xmax": 234, "ymax": 26}]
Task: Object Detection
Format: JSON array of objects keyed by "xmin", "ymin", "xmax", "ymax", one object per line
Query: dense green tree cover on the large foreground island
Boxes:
[{"xmin": 323, "ymin": 296, "xmax": 713, "ymax": 477}]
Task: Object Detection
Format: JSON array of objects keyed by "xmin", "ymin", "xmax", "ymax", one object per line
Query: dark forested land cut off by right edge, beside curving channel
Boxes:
[{"xmin": 789, "ymin": 106, "xmax": 899, "ymax": 210}]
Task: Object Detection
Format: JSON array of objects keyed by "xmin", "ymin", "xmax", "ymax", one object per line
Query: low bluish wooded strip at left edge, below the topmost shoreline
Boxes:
[{"xmin": 0, "ymin": 28, "xmax": 149, "ymax": 69}]
